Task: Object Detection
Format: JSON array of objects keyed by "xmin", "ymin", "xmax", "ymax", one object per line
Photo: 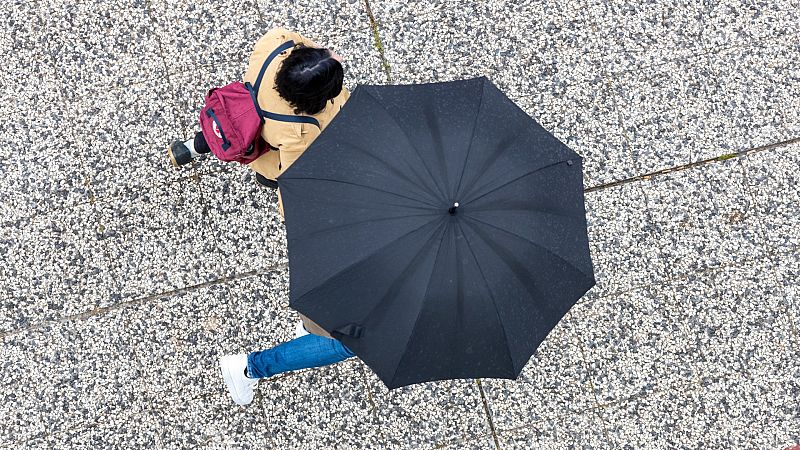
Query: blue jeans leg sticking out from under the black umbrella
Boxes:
[{"xmin": 247, "ymin": 334, "xmax": 355, "ymax": 378}]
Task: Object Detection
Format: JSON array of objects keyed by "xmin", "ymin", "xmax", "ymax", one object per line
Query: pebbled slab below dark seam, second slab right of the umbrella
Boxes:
[{"xmin": 641, "ymin": 158, "xmax": 768, "ymax": 277}]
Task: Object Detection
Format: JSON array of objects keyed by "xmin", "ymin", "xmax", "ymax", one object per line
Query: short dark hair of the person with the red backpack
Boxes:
[{"xmin": 275, "ymin": 46, "xmax": 344, "ymax": 115}]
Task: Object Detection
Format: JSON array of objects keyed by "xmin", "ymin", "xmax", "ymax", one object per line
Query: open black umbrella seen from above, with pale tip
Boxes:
[{"xmin": 278, "ymin": 77, "xmax": 594, "ymax": 389}]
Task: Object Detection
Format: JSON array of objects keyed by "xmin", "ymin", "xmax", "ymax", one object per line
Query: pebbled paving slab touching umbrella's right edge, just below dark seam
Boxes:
[{"xmin": 586, "ymin": 179, "xmax": 668, "ymax": 297}]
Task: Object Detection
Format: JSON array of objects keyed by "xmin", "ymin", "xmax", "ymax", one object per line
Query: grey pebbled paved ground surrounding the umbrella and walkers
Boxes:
[{"xmin": 0, "ymin": 0, "xmax": 800, "ymax": 450}]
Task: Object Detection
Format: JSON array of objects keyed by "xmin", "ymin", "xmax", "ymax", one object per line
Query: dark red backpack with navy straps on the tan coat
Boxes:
[{"xmin": 200, "ymin": 41, "xmax": 319, "ymax": 164}]
